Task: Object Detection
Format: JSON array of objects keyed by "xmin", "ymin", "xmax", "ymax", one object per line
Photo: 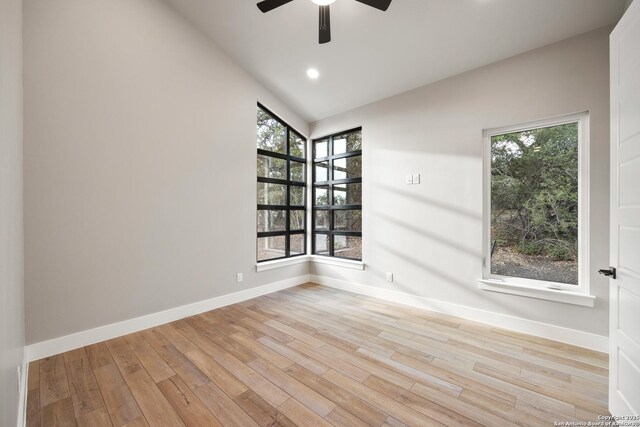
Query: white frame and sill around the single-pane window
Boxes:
[{"xmin": 481, "ymin": 111, "xmax": 593, "ymax": 296}]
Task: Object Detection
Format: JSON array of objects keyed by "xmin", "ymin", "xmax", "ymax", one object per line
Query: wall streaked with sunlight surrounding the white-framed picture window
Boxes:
[{"xmin": 311, "ymin": 28, "xmax": 610, "ymax": 335}]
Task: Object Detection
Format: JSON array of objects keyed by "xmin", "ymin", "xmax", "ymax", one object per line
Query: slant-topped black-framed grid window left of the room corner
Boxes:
[{"xmin": 256, "ymin": 104, "xmax": 307, "ymax": 262}]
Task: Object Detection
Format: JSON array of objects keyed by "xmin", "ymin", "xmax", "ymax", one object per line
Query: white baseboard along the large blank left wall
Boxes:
[{"xmin": 25, "ymin": 274, "xmax": 310, "ymax": 361}]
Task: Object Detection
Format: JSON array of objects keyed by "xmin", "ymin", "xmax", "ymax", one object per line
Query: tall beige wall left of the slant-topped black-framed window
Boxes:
[{"xmin": 24, "ymin": 0, "xmax": 308, "ymax": 343}]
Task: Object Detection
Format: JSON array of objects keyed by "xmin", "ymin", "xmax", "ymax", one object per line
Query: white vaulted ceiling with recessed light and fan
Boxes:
[{"xmin": 165, "ymin": 0, "xmax": 625, "ymax": 122}]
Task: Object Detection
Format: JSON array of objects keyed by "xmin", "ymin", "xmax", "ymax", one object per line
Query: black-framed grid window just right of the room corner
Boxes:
[{"xmin": 312, "ymin": 128, "xmax": 362, "ymax": 260}]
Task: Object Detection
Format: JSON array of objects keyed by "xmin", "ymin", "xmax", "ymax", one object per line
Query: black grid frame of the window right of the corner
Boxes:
[{"xmin": 309, "ymin": 126, "xmax": 363, "ymax": 262}]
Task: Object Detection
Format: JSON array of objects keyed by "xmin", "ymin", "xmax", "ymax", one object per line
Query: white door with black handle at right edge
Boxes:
[{"xmin": 609, "ymin": 0, "xmax": 640, "ymax": 416}]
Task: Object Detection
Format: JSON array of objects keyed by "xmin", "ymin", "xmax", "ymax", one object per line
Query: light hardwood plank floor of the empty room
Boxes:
[{"xmin": 27, "ymin": 284, "xmax": 608, "ymax": 427}]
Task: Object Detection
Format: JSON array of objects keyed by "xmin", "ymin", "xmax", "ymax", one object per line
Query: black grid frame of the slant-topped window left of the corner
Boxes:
[{"xmin": 255, "ymin": 102, "xmax": 309, "ymax": 264}]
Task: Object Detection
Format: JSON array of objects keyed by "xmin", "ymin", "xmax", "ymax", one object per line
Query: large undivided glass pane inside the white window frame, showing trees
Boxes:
[{"xmin": 491, "ymin": 123, "xmax": 578, "ymax": 284}]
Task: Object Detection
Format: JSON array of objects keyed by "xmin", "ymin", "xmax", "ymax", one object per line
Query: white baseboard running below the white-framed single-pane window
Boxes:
[{"xmin": 311, "ymin": 275, "xmax": 609, "ymax": 353}]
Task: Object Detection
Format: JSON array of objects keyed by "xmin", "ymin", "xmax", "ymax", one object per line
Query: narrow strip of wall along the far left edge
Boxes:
[{"xmin": 0, "ymin": 0, "xmax": 24, "ymax": 426}]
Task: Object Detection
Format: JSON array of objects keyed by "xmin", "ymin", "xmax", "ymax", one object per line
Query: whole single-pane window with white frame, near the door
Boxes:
[{"xmin": 483, "ymin": 113, "xmax": 589, "ymax": 293}]
